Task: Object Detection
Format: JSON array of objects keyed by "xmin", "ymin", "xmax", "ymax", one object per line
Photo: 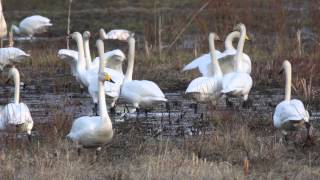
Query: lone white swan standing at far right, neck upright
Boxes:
[{"xmin": 273, "ymin": 60, "xmax": 310, "ymax": 134}]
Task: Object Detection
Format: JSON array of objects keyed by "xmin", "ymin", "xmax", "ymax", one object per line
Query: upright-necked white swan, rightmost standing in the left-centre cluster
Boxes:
[{"xmin": 121, "ymin": 37, "xmax": 167, "ymax": 108}]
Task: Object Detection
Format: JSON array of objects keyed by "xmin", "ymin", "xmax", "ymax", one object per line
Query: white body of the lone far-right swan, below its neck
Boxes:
[{"xmin": 273, "ymin": 99, "xmax": 309, "ymax": 128}]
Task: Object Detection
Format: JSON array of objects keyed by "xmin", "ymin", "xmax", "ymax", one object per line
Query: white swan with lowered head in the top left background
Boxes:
[{"xmin": 11, "ymin": 15, "xmax": 52, "ymax": 37}]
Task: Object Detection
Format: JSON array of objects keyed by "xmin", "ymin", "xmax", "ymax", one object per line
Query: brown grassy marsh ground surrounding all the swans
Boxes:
[{"xmin": 0, "ymin": 0, "xmax": 320, "ymax": 179}]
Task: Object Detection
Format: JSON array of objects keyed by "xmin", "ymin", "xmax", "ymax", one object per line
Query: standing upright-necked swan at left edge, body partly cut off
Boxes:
[{"xmin": 0, "ymin": 67, "xmax": 33, "ymax": 137}]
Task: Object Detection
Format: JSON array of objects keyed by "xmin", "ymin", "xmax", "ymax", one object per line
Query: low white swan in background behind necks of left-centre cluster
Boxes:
[{"xmin": 100, "ymin": 28, "xmax": 134, "ymax": 41}]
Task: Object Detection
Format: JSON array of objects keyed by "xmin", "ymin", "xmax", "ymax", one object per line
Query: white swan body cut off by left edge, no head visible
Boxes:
[{"xmin": 0, "ymin": 47, "xmax": 30, "ymax": 70}]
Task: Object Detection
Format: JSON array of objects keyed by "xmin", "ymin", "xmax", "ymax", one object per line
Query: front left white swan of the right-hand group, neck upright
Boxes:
[{"xmin": 186, "ymin": 33, "xmax": 222, "ymax": 104}]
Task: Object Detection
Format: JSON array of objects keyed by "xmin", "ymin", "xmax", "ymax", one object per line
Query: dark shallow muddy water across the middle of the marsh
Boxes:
[{"xmin": 0, "ymin": 78, "xmax": 320, "ymax": 137}]
